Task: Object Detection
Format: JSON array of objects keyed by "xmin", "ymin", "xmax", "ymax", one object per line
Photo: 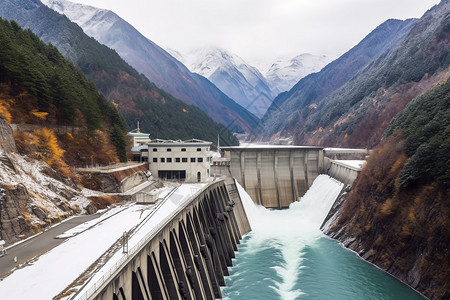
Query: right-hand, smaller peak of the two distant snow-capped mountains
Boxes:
[{"xmin": 265, "ymin": 53, "xmax": 330, "ymax": 93}]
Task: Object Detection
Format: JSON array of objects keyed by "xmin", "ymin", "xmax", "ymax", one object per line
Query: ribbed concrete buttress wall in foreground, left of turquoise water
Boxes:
[{"xmin": 81, "ymin": 178, "xmax": 250, "ymax": 300}]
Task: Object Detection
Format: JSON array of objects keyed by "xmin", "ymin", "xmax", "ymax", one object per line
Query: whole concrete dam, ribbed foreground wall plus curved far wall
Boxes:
[{"xmin": 69, "ymin": 146, "xmax": 359, "ymax": 300}]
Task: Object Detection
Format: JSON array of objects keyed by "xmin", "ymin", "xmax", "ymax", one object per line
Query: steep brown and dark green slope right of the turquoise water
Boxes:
[{"xmin": 327, "ymin": 79, "xmax": 450, "ymax": 299}]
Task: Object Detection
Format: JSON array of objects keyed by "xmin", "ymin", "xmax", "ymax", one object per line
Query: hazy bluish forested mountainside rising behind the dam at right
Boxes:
[{"xmin": 263, "ymin": 0, "xmax": 450, "ymax": 148}]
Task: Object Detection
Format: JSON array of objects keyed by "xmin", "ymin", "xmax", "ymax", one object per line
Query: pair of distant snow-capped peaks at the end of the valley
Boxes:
[{"xmin": 172, "ymin": 45, "xmax": 328, "ymax": 118}]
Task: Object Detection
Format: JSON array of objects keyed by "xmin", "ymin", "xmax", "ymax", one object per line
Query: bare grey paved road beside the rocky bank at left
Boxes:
[{"xmin": 0, "ymin": 214, "xmax": 100, "ymax": 279}]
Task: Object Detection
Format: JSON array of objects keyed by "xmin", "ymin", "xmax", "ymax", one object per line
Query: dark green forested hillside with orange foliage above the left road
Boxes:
[{"xmin": 0, "ymin": 19, "xmax": 126, "ymax": 164}]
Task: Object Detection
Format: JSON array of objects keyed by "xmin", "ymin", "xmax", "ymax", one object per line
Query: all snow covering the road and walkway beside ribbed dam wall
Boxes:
[{"xmin": 0, "ymin": 184, "xmax": 206, "ymax": 300}]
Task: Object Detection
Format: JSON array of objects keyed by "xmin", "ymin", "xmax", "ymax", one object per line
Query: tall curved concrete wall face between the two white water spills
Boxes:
[{"xmin": 221, "ymin": 146, "xmax": 323, "ymax": 208}]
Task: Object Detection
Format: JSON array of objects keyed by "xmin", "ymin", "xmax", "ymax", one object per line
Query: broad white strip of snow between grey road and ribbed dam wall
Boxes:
[{"xmin": 0, "ymin": 205, "xmax": 155, "ymax": 299}]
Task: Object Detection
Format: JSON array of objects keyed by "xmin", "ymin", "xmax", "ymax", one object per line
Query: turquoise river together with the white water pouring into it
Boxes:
[{"xmin": 222, "ymin": 175, "xmax": 423, "ymax": 300}]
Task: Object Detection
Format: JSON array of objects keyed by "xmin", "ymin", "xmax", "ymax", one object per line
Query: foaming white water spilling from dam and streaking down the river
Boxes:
[{"xmin": 238, "ymin": 175, "xmax": 342, "ymax": 299}]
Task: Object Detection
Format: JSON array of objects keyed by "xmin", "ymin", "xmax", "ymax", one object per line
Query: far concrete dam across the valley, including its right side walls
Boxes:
[{"xmin": 211, "ymin": 145, "xmax": 368, "ymax": 208}]
